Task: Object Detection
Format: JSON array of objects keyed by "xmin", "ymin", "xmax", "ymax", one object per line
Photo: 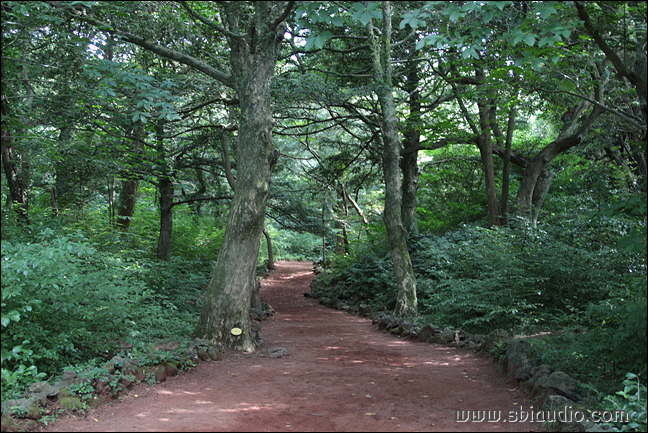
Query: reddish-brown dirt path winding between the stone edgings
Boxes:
[{"xmin": 50, "ymin": 262, "xmax": 541, "ymax": 431}]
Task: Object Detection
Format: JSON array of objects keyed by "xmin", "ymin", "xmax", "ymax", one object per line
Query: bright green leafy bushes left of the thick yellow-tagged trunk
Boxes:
[{"xmin": 2, "ymin": 229, "xmax": 206, "ymax": 396}]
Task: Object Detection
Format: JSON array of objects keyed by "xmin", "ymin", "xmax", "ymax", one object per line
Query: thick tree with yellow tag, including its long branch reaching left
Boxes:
[{"xmin": 50, "ymin": 1, "xmax": 294, "ymax": 351}]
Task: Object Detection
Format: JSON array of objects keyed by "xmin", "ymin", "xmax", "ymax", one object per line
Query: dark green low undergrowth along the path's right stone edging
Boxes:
[{"xmin": 318, "ymin": 223, "xmax": 647, "ymax": 392}]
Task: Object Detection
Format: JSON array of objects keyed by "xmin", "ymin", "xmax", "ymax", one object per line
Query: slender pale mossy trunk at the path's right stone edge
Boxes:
[{"xmin": 367, "ymin": 1, "xmax": 417, "ymax": 316}]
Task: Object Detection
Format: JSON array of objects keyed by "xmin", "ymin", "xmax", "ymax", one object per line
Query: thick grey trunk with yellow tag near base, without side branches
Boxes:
[{"xmin": 193, "ymin": 2, "xmax": 285, "ymax": 351}]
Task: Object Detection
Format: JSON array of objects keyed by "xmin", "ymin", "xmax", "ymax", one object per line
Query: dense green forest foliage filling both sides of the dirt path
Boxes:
[{"xmin": 1, "ymin": 2, "xmax": 648, "ymax": 428}]
